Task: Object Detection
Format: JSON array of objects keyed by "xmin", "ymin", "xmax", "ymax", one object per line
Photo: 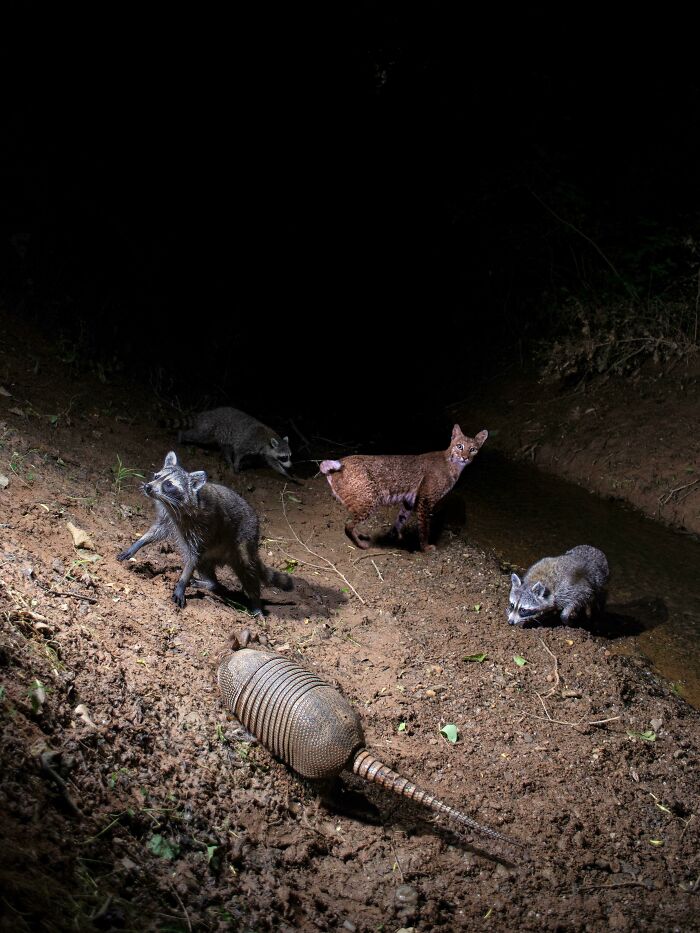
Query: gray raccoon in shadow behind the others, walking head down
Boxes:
[{"xmin": 174, "ymin": 408, "xmax": 292, "ymax": 476}]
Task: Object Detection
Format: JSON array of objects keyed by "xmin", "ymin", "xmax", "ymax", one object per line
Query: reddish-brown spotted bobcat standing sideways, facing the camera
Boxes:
[{"xmin": 320, "ymin": 424, "xmax": 489, "ymax": 551}]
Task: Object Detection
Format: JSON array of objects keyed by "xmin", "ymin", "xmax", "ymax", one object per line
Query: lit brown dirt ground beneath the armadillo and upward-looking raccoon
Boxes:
[{"xmin": 0, "ymin": 318, "xmax": 700, "ymax": 933}]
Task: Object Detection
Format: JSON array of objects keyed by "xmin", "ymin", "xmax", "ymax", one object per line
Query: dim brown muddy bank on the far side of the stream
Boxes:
[{"xmin": 449, "ymin": 356, "xmax": 700, "ymax": 535}]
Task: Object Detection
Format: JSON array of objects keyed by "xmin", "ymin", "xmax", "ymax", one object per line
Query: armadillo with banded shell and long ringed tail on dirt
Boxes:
[{"xmin": 217, "ymin": 647, "xmax": 521, "ymax": 845}]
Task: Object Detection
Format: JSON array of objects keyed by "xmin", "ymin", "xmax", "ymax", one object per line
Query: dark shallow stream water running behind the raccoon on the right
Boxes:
[{"xmin": 455, "ymin": 451, "xmax": 700, "ymax": 708}]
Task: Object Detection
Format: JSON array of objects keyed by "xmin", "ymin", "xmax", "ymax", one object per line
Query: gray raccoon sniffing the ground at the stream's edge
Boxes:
[{"xmin": 508, "ymin": 544, "xmax": 609, "ymax": 625}]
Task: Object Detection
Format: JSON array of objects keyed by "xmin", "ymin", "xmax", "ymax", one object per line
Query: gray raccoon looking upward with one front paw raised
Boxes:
[{"xmin": 117, "ymin": 451, "xmax": 294, "ymax": 615}]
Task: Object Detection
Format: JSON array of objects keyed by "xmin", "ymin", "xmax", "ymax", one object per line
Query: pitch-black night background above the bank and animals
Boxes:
[{"xmin": 0, "ymin": 3, "xmax": 700, "ymax": 447}]
